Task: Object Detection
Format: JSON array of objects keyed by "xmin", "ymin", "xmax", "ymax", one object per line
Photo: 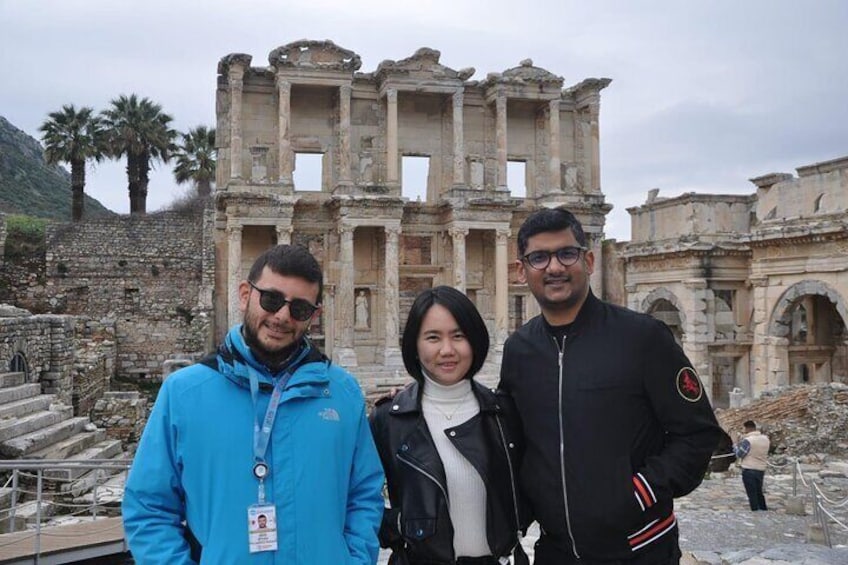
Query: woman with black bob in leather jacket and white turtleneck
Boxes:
[{"xmin": 371, "ymin": 286, "xmax": 528, "ymax": 565}]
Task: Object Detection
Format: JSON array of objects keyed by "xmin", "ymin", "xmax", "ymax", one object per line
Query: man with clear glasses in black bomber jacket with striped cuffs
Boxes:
[{"xmin": 500, "ymin": 209, "xmax": 721, "ymax": 565}]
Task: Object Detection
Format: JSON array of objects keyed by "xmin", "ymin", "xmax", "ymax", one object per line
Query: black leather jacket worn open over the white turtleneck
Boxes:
[{"xmin": 371, "ymin": 380, "xmax": 525, "ymax": 565}]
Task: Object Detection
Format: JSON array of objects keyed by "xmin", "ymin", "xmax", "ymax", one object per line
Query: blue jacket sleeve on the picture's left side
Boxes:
[{"xmin": 121, "ymin": 381, "xmax": 194, "ymax": 565}]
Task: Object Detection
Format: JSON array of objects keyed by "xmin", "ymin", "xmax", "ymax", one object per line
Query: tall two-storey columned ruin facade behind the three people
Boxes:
[{"xmin": 214, "ymin": 40, "xmax": 611, "ymax": 378}]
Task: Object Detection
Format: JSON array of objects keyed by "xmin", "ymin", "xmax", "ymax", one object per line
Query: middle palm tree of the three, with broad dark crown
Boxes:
[{"xmin": 102, "ymin": 94, "xmax": 177, "ymax": 214}]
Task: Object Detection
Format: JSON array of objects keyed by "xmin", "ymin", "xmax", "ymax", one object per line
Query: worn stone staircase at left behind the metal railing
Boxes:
[{"xmin": 0, "ymin": 373, "xmax": 129, "ymax": 531}]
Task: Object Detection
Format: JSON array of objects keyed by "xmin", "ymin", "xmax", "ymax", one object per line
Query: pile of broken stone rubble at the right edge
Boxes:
[{"xmin": 716, "ymin": 382, "xmax": 848, "ymax": 457}]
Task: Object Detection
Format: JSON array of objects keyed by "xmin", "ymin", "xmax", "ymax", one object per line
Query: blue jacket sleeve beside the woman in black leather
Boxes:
[{"xmin": 344, "ymin": 402, "xmax": 384, "ymax": 565}]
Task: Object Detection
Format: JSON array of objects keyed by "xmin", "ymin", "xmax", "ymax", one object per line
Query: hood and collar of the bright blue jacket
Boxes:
[{"xmin": 217, "ymin": 324, "xmax": 330, "ymax": 389}]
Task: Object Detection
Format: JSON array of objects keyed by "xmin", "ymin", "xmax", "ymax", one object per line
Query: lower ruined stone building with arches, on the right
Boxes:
[{"xmin": 624, "ymin": 157, "xmax": 848, "ymax": 406}]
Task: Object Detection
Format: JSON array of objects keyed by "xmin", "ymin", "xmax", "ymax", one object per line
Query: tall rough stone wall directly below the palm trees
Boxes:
[{"xmin": 45, "ymin": 213, "xmax": 214, "ymax": 378}]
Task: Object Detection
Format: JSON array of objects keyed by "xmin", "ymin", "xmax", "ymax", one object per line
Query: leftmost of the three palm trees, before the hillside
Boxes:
[{"xmin": 38, "ymin": 104, "xmax": 104, "ymax": 222}]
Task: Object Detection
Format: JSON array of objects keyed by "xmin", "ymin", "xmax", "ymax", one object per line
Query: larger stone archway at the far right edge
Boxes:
[{"xmin": 768, "ymin": 280, "xmax": 848, "ymax": 385}]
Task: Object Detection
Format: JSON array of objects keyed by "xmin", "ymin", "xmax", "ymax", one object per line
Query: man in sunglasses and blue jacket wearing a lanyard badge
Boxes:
[{"xmin": 123, "ymin": 245, "xmax": 384, "ymax": 565}]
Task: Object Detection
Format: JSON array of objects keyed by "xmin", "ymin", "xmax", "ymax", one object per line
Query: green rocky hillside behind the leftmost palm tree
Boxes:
[{"xmin": 0, "ymin": 116, "xmax": 115, "ymax": 221}]
